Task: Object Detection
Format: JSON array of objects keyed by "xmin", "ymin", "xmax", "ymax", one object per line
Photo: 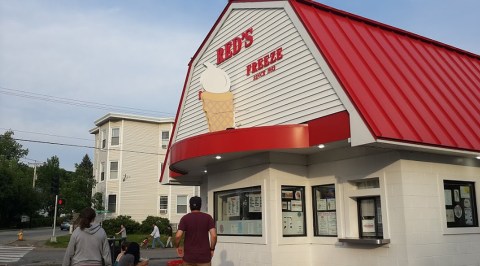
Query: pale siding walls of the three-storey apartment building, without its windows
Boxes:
[{"xmin": 93, "ymin": 115, "xmax": 196, "ymax": 223}]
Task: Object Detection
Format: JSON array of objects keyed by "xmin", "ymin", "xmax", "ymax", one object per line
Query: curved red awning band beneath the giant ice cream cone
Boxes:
[{"xmin": 170, "ymin": 111, "xmax": 350, "ymax": 177}]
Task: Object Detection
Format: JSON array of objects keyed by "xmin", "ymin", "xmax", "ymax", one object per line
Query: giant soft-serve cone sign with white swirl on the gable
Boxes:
[{"xmin": 200, "ymin": 62, "xmax": 234, "ymax": 132}]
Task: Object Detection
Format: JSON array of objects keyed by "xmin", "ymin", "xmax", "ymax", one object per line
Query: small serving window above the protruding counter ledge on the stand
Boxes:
[{"xmin": 357, "ymin": 196, "xmax": 383, "ymax": 239}]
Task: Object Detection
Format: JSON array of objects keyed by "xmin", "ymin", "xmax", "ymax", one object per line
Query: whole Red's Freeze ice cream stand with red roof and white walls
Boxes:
[{"xmin": 161, "ymin": 0, "xmax": 480, "ymax": 266}]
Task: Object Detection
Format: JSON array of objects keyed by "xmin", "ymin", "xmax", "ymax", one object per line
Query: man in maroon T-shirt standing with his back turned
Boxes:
[{"xmin": 175, "ymin": 196, "xmax": 217, "ymax": 266}]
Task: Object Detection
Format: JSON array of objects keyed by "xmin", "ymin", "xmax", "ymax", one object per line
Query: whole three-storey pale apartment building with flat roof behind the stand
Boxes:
[{"xmin": 90, "ymin": 113, "xmax": 199, "ymax": 224}]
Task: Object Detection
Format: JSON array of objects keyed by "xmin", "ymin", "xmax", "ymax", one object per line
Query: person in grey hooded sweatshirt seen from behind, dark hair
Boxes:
[{"xmin": 62, "ymin": 207, "xmax": 112, "ymax": 266}]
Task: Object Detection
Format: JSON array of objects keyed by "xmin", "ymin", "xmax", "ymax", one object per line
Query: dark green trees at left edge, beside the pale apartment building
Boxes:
[{"xmin": 0, "ymin": 131, "xmax": 97, "ymax": 228}]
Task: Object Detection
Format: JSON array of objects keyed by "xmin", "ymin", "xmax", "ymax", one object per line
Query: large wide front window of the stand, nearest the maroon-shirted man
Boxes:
[{"xmin": 213, "ymin": 186, "xmax": 262, "ymax": 236}]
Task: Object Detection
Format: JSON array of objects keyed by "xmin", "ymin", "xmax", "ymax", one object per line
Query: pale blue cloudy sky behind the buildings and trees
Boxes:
[{"xmin": 0, "ymin": 0, "xmax": 480, "ymax": 171}]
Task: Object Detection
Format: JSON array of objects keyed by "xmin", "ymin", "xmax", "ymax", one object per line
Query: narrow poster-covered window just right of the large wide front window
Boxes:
[{"xmin": 281, "ymin": 186, "xmax": 307, "ymax": 236}]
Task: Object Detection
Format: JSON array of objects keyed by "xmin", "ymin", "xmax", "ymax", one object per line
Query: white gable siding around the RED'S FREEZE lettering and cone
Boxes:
[{"xmin": 176, "ymin": 8, "xmax": 345, "ymax": 141}]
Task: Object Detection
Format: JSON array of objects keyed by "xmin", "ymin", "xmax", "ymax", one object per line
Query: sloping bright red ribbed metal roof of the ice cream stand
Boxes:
[{"xmin": 290, "ymin": 0, "xmax": 480, "ymax": 151}]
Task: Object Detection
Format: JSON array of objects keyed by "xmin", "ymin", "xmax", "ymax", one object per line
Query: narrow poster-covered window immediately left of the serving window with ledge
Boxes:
[{"xmin": 312, "ymin": 184, "xmax": 337, "ymax": 236}]
